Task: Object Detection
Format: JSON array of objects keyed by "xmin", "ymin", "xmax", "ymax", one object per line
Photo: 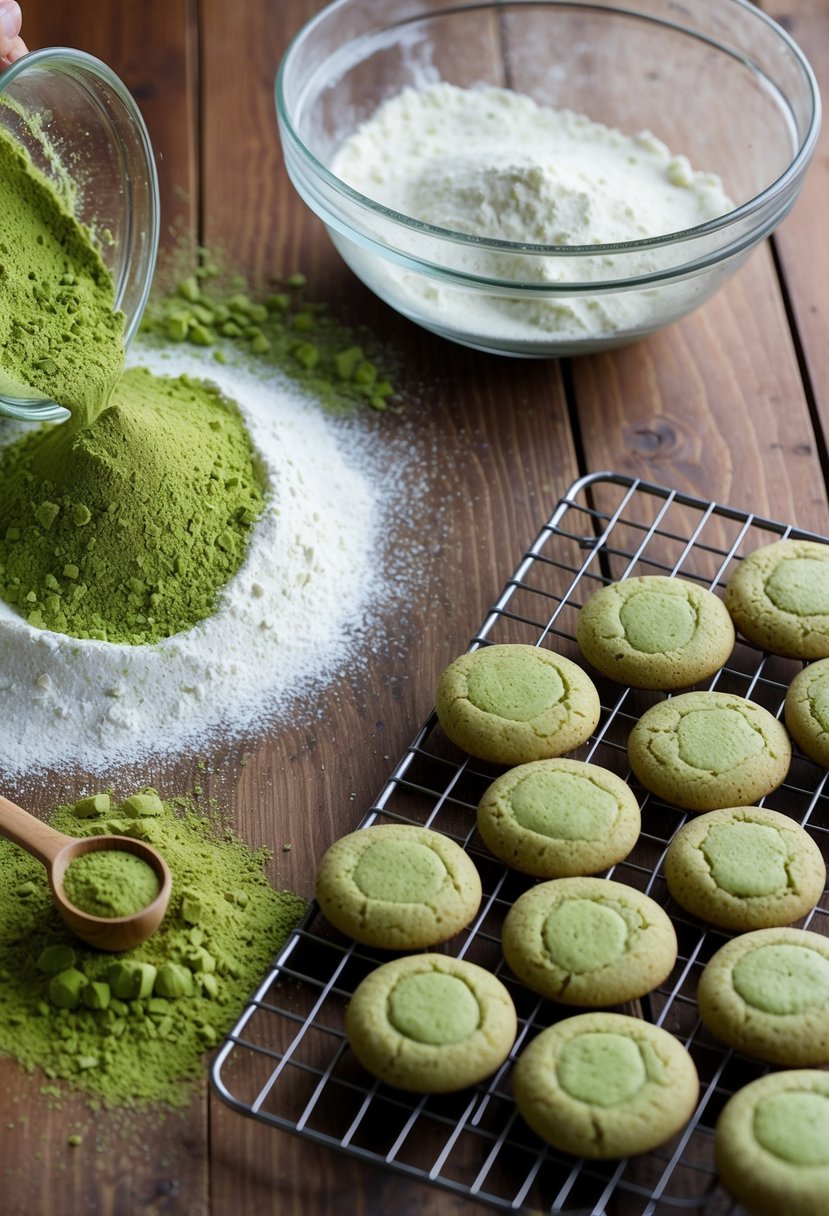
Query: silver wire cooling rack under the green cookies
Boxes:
[{"xmin": 213, "ymin": 473, "xmax": 829, "ymax": 1216}]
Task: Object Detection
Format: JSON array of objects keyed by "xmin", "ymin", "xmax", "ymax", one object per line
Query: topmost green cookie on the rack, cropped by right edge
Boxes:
[{"xmin": 726, "ymin": 540, "xmax": 829, "ymax": 659}]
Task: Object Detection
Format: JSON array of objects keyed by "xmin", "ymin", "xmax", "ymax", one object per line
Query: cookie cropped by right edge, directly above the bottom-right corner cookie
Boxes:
[{"xmin": 697, "ymin": 929, "xmax": 829, "ymax": 1068}]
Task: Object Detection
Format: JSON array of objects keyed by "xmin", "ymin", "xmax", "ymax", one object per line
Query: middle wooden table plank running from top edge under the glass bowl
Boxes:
[{"xmin": 196, "ymin": 0, "xmax": 577, "ymax": 1216}]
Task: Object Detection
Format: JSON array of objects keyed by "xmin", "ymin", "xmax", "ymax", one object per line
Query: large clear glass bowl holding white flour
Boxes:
[{"xmin": 276, "ymin": 0, "xmax": 820, "ymax": 356}]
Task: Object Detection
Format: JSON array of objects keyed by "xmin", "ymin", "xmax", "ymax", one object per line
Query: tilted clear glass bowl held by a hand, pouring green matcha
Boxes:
[{"xmin": 0, "ymin": 47, "xmax": 159, "ymax": 421}]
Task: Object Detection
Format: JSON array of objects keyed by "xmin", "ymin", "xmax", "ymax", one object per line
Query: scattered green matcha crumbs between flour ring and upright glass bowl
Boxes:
[{"xmin": 142, "ymin": 253, "xmax": 397, "ymax": 413}]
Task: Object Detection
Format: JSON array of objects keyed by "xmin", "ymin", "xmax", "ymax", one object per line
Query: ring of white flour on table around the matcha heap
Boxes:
[{"xmin": 0, "ymin": 349, "xmax": 391, "ymax": 777}]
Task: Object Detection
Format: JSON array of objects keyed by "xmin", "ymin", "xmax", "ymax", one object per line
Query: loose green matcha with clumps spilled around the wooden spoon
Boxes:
[{"xmin": 0, "ymin": 792, "xmax": 305, "ymax": 1107}]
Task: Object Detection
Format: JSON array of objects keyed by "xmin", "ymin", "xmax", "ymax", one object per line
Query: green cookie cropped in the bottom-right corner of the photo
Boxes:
[{"xmin": 714, "ymin": 1069, "xmax": 829, "ymax": 1216}]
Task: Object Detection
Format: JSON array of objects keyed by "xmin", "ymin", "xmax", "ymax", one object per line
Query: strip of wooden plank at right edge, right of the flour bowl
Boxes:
[{"xmin": 762, "ymin": 0, "xmax": 829, "ymax": 428}]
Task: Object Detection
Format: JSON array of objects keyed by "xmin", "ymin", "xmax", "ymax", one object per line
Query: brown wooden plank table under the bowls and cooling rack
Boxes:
[{"xmin": 6, "ymin": 0, "xmax": 829, "ymax": 1216}]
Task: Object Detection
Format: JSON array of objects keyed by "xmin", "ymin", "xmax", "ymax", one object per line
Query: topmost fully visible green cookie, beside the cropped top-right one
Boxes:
[{"xmin": 576, "ymin": 574, "xmax": 734, "ymax": 689}]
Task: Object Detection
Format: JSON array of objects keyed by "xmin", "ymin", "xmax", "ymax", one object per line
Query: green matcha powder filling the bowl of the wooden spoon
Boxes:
[{"xmin": 63, "ymin": 849, "xmax": 162, "ymax": 917}]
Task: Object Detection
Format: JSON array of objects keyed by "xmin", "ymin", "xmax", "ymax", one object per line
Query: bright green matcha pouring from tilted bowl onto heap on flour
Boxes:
[{"xmin": 0, "ymin": 117, "xmax": 264, "ymax": 644}]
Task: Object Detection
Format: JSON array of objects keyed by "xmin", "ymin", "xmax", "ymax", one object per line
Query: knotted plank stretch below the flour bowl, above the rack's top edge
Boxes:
[{"xmin": 573, "ymin": 239, "xmax": 829, "ymax": 531}]
